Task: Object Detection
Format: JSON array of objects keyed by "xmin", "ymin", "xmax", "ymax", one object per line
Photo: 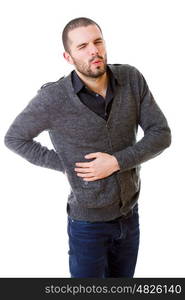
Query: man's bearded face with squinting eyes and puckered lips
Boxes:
[{"xmin": 64, "ymin": 25, "xmax": 107, "ymax": 78}]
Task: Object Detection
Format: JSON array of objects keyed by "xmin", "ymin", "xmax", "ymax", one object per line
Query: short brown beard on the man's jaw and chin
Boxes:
[{"xmin": 71, "ymin": 54, "xmax": 107, "ymax": 78}]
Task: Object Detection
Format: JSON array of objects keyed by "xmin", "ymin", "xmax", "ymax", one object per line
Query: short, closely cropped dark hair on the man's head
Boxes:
[{"xmin": 62, "ymin": 17, "xmax": 102, "ymax": 52}]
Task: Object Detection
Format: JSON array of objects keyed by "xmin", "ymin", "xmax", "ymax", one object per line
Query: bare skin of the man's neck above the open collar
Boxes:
[{"xmin": 76, "ymin": 70, "xmax": 108, "ymax": 96}]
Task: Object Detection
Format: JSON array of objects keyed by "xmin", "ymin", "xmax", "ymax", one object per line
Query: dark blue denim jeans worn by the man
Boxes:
[{"xmin": 67, "ymin": 204, "xmax": 140, "ymax": 278}]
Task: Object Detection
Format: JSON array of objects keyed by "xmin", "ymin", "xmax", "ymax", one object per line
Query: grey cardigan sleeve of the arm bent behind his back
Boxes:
[{"xmin": 4, "ymin": 88, "xmax": 64, "ymax": 173}]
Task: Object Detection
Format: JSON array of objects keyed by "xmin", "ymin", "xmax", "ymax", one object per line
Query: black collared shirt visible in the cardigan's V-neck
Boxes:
[{"xmin": 72, "ymin": 66, "xmax": 117, "ymax": 120}]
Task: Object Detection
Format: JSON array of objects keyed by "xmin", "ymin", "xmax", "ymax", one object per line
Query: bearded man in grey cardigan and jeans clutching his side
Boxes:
[{"xmin": 5, "ymin": 18, "xmax": 171, "ymax": 278}]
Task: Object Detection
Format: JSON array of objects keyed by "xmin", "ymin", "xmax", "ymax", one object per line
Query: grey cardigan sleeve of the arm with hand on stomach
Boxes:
[{"xmin": 113, "ymin": 68, "xmax": 171, "ymax": 173}]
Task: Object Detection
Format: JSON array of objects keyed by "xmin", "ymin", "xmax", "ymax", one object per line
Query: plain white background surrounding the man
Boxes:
[{"xmin": 0, "ymin": 0, "xmax": 185, "ymax": 277}]
